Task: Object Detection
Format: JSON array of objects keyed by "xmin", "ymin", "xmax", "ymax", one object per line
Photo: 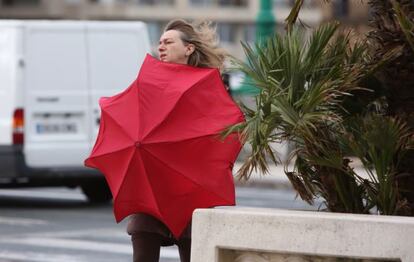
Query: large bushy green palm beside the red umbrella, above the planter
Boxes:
[{"xmin": 229, "ymin": 23, "xmax": 372, "ymax": 213}]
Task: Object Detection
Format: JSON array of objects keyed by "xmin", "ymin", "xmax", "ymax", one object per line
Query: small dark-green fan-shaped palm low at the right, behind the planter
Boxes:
[{"xmin": 342, "ymin": 115, "xmax": 414, "ymax": 215}]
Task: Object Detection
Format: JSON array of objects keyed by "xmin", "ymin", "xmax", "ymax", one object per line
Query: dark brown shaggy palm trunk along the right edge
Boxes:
[{"xmin": 368, "ymin": 0, "xmax": 414, "ymax": 215}]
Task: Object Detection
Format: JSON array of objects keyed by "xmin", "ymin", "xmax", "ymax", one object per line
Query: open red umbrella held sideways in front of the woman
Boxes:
[{"xmin": 85, "ymin": 55, "xmax": 244, "ymax": 238}]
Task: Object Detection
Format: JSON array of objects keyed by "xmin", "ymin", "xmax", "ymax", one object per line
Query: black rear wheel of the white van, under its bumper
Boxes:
[{"xmin": 81, "ymin": 180, "xmax": 112, "ymax": 204}]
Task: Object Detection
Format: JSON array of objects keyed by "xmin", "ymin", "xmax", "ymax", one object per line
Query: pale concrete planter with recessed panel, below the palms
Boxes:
[{"xmin": 191, "ymin": 207, "xmax": 414, "ymax": 262}]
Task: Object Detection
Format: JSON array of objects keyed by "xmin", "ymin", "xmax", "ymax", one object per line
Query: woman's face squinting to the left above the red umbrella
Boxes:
[{"xmin": 158, "ymin": 30, "xmax": 194, "ymax": 64}]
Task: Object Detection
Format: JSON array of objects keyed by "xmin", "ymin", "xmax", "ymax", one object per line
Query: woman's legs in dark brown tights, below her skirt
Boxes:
[{"xmin": 131, "ymin": 232, "xmax": 191, "ymax": 262}]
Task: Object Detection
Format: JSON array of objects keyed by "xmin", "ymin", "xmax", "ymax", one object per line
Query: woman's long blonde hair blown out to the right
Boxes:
[{"xmin": 164, "ymin": 19, "xmax": 227, "ymax": 70}]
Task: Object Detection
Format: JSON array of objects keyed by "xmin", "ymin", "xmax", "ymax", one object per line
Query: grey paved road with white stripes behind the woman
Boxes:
[{"xmin": 0, "ymin": 187, "xmax": 317, "ymax": 262}]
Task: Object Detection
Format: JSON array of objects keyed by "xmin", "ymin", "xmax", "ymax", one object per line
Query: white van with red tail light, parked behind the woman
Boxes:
[{"xmin": 0, "ymin": 20, "xmax": 150, "ymax": 202}]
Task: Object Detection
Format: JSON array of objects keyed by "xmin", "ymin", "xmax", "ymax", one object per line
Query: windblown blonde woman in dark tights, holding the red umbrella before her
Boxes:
[{"xmin": 127, "ymin": 20, "xmax": 226, "ymax": 262}]
